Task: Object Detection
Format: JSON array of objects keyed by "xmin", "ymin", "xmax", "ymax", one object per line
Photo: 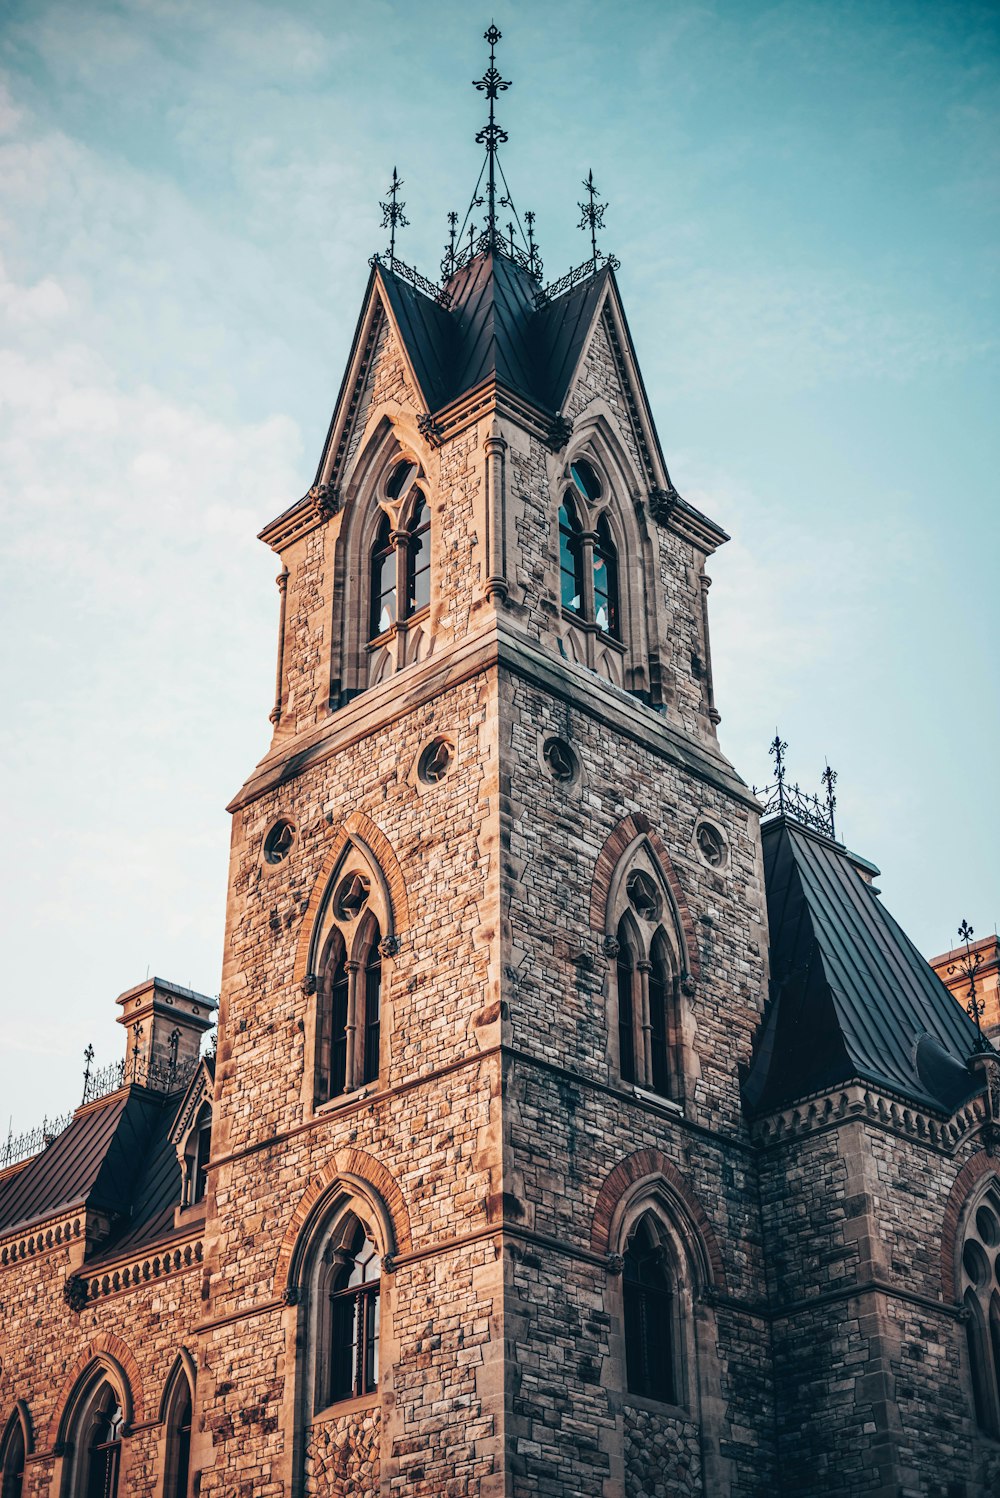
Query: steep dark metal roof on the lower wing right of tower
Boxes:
[{"xmin": 744, "ymin": 818, "xmax": 981, "ymax": 1113}]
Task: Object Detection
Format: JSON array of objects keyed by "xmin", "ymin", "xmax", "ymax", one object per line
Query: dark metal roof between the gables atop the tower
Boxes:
[{"xmin": 380, "ymin": 253, "xmax": 611, "ymax": 412}]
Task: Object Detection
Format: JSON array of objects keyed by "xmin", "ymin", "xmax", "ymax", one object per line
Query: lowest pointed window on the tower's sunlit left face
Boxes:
[{"xmin": 316, "ymin": 1212, "xmax": 382, "ymax": 1410}]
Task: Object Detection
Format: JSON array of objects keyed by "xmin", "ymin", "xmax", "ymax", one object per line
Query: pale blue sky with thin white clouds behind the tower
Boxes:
[{"xmin": 0, "ymin": 0, "xmax": 1000, "ymax": 1134}]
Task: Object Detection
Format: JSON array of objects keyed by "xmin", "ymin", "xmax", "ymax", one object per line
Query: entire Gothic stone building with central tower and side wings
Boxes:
[{"xmin": 0, "ymin": 35, "xmax": 1000, "ymax": 1498}]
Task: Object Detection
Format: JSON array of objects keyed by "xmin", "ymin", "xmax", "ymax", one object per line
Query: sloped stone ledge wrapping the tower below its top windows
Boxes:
[{"xmin": 228, "ymin": 616, "xmax": 760, "ymax": 813}]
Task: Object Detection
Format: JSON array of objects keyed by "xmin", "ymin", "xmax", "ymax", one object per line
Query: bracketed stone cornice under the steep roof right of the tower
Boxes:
[{"xmin": 750, "ymin": 1080, "xmax": 987, "ymax": 1156}]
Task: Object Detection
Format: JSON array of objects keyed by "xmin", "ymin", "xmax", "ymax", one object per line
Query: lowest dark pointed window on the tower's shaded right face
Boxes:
[{"xmin": 621, "ymin": 1213, "xmax": 678, "ymax": 1404}]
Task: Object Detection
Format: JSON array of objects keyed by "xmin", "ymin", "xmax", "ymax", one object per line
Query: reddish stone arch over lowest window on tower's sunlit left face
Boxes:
[{"xmin": 274, "ymin": 1149, "xmax": 413, "ymax": 1291}]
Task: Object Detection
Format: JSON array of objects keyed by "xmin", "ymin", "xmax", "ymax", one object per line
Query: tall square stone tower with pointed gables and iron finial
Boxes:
[{"xmin": 196, "ymin": 35, "xmax": 772, "ymax": 1498}]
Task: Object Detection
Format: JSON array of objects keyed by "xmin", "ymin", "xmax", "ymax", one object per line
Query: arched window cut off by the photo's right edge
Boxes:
[{"xmin": 960, "ymin": 1180, "xmax": 1000, "ymax": 1438}]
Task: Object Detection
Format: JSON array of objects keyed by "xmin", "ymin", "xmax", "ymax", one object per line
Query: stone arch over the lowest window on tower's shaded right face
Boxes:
[{"xmin": 590, "ymin": 1149, "xmax": 726, "ymax": 1290}]
